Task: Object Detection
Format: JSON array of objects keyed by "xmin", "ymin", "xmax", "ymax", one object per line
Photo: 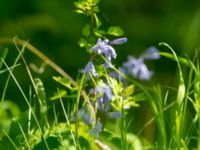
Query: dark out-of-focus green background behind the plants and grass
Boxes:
[{"xmin": 0, "ymin": 0, "xmax": 200, "ymax": 108}]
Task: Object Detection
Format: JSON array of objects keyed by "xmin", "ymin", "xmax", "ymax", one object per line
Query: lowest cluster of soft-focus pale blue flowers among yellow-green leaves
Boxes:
[{"xmin": 76, "ymin": 82, "xmax": 121, "ymax": 137}]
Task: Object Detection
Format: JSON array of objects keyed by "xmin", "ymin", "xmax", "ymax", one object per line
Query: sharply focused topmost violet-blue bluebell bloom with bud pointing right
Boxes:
[{"xmin": 90, "ymin": 38, "xmax": 127, "ymax": 68}]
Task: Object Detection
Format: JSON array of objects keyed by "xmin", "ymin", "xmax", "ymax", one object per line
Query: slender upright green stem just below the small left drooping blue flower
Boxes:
[{"xmin": 75, "ymin": 73, "xmax": 85, "ymax": 149}]
